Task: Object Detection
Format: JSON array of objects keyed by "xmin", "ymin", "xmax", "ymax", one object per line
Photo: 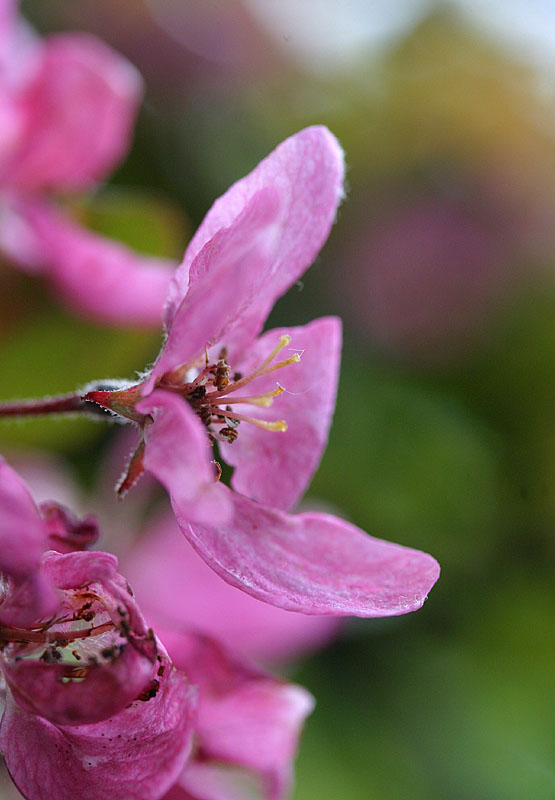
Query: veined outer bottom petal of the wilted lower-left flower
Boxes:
[{"xmin": 0, "ymin": 666, "xmax": 196, "ymax": 800}]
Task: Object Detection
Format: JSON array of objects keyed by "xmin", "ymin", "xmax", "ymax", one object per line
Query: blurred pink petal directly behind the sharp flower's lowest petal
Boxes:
[{"xmin": 122, "ymin": 514, "xmax": 339, "ymax": 663}]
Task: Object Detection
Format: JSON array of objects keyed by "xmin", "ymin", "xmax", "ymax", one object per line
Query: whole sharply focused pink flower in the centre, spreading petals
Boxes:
[{"xmin": 85, "ymin": 127, "xmax": 439, "ymax": 617}]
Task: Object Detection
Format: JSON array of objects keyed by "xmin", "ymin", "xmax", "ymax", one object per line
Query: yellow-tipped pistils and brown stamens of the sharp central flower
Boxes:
[{"xmin": 163, "ymin": 334, "xmax": 301, "ymax": 443}]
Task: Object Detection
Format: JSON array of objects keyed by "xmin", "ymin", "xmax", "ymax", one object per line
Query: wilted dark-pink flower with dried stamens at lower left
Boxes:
[{"xmin": 0, "ymin": 461, "xmax": 196, "ymax": 800}]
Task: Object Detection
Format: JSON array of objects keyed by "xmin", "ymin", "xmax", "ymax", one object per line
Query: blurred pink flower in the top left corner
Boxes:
[{"xmin": 0, "ymin": 0, "xmax": 173, "ymax": 325}]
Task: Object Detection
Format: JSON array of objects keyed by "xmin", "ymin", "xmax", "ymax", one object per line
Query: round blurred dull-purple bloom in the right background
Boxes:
[{"xmin": 337, "ymin": 188, "xmax": 545, "ymax": 362}]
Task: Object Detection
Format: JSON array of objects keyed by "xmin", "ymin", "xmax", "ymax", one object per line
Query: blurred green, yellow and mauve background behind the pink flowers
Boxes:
[{"xmin": 4, "ymin": 0, "xmax": 555, "ymax": 800}]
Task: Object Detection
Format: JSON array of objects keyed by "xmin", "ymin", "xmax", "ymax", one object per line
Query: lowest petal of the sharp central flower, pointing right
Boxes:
[{"xmin": 180, "ymin": 487, "xmax": 439, "ymax": 617}]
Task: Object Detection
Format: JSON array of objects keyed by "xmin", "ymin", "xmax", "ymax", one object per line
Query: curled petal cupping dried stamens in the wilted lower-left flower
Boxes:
[{"xmin": 1, "ymin": 551, "xmax": 159, "ymax": 725}]
